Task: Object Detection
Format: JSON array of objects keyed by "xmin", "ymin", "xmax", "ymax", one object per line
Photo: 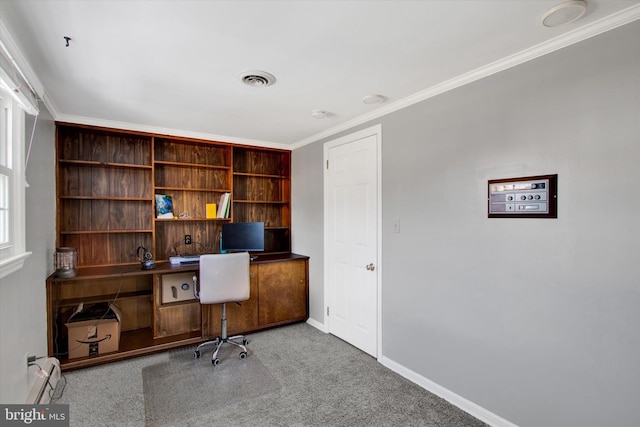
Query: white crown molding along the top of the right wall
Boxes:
[{"xmin": 291, "ymin": 4, "xmax": 640, "ymax": 150}]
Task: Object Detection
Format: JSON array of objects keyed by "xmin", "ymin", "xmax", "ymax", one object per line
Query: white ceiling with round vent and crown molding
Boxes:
[{"xmin": 0, "ymin": 0, "xmax": 640, "ymax": 148}]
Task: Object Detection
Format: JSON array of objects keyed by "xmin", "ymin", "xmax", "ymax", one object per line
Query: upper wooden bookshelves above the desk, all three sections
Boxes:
[{"xmin": 57, "ymin": 123, "xmax": 291, "ymax": 268}]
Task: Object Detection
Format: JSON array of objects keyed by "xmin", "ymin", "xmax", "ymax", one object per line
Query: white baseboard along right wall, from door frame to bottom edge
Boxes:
[{"xmin": 378, "ymin": 356, "xmax": 518, "ymax": 427}]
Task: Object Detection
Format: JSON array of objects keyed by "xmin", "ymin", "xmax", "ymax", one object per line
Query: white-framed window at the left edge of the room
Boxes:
[{"xmin": 0, "ymin": 85, "xmax": 30, "ymax": 278}]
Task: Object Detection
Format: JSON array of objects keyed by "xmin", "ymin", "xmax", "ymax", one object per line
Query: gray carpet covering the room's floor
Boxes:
[{"xmin": 58, "ymin": 323, "xmax": 485, "ymax": 427}]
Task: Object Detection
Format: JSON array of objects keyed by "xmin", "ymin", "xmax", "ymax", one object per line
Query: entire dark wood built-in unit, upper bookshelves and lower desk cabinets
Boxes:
[{"xmin": 47, "ymin": 123, "xmax": 309, "ymax": 369}]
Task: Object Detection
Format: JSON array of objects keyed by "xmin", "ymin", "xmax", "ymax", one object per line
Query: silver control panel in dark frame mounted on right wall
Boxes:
[{"xmin": 488, "ymin": 175, "xmax": 558, "ymax": 218}]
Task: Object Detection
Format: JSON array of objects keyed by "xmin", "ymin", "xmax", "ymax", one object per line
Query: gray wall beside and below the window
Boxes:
[{"xmin": 0, "ymin": 106, "xmax": 56, "ymax": 403}]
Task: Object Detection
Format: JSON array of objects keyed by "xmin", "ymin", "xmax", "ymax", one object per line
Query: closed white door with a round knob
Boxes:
[{"xmin": 325, "ymin": 126, "xmax": 381, "ymax": 357}]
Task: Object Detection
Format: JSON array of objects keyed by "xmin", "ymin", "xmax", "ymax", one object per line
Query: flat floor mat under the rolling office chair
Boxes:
[{"xmin": 142, "ymin": 347, "xmax": 282, "ymax": 426}]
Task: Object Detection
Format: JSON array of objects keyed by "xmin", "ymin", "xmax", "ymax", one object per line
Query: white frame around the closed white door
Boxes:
[{"xmin": 322, "ymin": 124, "xmax": 382, "ymax": 360}]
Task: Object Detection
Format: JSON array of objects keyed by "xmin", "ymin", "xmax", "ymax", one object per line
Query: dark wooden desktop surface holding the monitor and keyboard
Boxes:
[{"xmin": 47, "ymin": 253, "xmax": 309, "ymax": 282}]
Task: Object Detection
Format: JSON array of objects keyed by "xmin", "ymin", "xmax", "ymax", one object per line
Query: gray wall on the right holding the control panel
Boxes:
[{"xmin": 292, "ymin": 22, "xmax": 640, "ymax": 426}]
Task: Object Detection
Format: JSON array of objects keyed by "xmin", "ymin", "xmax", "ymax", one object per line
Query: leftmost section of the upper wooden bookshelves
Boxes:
[{"xmin": 57, "ymin": 126, "xmax": 154, "ymax": 266}]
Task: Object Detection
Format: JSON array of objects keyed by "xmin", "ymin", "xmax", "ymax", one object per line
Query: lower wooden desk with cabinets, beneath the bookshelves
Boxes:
[{"xmin": 46, "ymin": 254, "xmax": 309, "ymax": 370}]
